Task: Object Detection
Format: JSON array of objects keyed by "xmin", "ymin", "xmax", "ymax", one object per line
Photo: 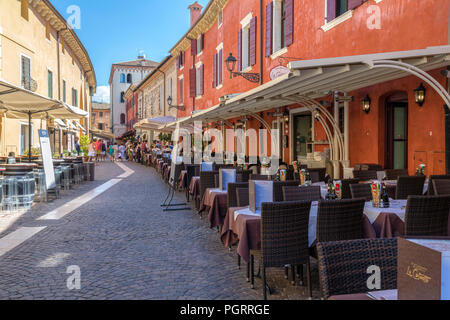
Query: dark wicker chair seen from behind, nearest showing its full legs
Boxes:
[{"xmin": 250, "ymin": 201, "xmax": 312, "ymax": 300}]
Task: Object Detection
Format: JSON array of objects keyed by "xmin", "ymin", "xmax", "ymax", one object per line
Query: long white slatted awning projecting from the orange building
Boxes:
[{"xmin": 163, "ymin": 46, "xmax": 450, "ymax": 128}]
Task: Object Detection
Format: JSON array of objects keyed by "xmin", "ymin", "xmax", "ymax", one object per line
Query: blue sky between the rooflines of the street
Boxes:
[{"xmin": 50, "ymin": 0, "xmax": 209, "ymax": 102}]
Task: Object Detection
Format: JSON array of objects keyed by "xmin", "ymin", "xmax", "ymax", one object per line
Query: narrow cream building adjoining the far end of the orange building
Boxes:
[{"xmin": 134, "ymin": 56, "xmax": 178, "ymax": 140}]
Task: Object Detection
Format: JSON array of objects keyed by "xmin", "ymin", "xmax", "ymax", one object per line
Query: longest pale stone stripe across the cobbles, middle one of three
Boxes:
[{"xmin": 38, "ymin": 179, "xmax": 122, "ymax": 220}]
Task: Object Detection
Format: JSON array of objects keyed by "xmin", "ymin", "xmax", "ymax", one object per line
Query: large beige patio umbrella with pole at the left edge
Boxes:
[{"xmin": 0, "ymin": 79, "xmax": 89, "ymax": 161}]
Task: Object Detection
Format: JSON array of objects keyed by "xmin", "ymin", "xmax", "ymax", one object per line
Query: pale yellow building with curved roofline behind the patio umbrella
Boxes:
[{"xmin": 0, "ymin": 0, "xmax": 96, "ymax": 155}]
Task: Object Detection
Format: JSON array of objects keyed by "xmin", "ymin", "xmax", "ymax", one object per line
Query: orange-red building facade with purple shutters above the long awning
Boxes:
[{"xmin": 171, "ymin": 0, "xmax": 450, "ymax": 174}]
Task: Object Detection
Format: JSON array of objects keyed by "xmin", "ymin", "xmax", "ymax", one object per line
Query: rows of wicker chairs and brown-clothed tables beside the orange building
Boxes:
[{"xmin": 146, "ymin": 152, "xmax": 450, "ymax": 300}]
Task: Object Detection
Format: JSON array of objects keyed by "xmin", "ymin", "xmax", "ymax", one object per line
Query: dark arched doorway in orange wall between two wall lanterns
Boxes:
[{"xmin": 385, "ymin": 93, "xmax": 408, "ymax": 169}]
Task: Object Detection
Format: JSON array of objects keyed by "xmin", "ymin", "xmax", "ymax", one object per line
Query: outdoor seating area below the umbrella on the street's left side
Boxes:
[{"xmin": 0, "ymin": 157, "xmax": 95, "ymax": 213}]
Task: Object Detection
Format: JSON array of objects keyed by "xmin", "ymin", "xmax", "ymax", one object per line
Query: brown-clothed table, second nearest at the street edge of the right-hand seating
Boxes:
[{"xmin": 200, "ymin": 188, "xmax": 227, "ymax": 228}]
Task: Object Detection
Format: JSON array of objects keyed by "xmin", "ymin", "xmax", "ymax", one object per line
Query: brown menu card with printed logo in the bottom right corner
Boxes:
[{"xmin": 397, "ymin": 238, "xmax": 450, "ymax": 300}]
